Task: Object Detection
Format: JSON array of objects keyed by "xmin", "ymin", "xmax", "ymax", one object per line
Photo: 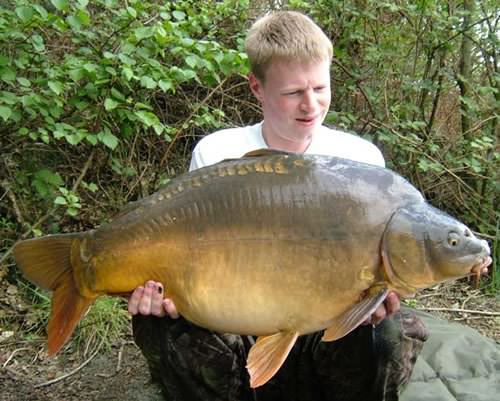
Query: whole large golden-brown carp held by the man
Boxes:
[{"xmin": 14, "ymin": 152, "xmax": 491, "ymax": 387}]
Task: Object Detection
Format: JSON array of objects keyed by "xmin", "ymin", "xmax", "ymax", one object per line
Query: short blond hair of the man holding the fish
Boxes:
[{"xmin": 245, "ymin": 11, "xmax": 333, "ymax": 81}]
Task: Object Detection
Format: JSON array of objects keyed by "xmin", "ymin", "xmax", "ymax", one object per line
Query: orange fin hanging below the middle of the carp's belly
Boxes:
[{"xmin": 247, "ymin": 332, "xmax": 299, "ymax": 388}]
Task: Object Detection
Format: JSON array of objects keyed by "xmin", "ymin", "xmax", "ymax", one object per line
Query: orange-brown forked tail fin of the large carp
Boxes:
[{"xmin": 14, "ymin": 234, "xmax": 95, "ymax": 355}]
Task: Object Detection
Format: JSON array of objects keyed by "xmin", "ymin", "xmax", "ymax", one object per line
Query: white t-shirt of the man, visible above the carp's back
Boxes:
[{"xmin": 189, "ymin": 122, "xmax": 385, "ymax": 171}]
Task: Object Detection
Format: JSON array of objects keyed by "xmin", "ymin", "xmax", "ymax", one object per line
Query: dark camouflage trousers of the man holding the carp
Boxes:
[{"xmin": 133, "ymin": 309, "xmax": 427, "ymax": 401}]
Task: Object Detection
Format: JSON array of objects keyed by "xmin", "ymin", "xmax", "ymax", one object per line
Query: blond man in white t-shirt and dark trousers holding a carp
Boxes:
[{"xmin": 129, "ymin": 12, "xmax": 426, "ymax": 401}]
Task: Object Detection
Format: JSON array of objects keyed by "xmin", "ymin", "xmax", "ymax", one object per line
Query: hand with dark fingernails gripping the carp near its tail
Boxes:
[{"xmin": 128, "ymin": 280, "xmax": 179, "ymax": 319}]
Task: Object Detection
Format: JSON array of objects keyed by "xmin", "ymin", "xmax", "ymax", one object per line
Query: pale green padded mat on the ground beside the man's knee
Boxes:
[{"xmin": 401, "ymin": 311, "xmax": 500, "ymax": 401}]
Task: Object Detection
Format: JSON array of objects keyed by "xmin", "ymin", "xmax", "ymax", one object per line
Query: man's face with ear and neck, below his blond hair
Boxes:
[{"xmin": 249, "ymin": 60, "xmax": 331, "ymax": 152}]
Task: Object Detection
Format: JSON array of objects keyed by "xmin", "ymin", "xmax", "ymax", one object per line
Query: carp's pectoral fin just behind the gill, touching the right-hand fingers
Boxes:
[{"xmin": 321, "ymin": 286, "xmax": 389, "ymax": 341}]
